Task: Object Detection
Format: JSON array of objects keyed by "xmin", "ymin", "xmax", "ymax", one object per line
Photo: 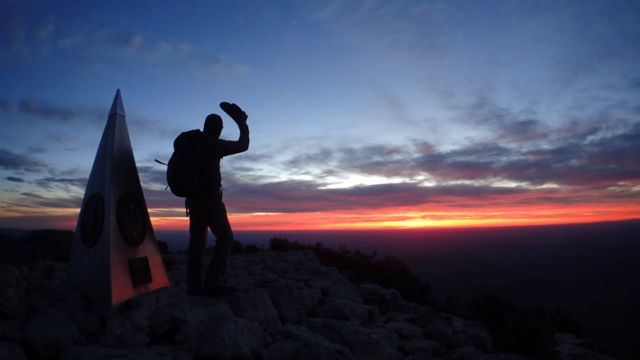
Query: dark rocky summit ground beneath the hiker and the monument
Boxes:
[{"xmin": 0, "ymin": 251, "xmax": 611, "ymax": 360}]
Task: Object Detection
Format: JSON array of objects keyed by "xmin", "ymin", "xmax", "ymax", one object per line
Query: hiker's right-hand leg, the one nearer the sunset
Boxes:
[{"xmin": 205, "ymin": 201, "xmax": 233, "ymax": 291}]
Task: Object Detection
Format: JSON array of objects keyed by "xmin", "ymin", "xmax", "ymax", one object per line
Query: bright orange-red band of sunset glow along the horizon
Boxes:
[{"xmin": 145, "ymin": 204, "xmax": 640, "ymax": 231}]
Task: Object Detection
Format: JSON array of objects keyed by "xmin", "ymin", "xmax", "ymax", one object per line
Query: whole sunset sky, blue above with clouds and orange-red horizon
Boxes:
[{"xmin": 0, "ymin": 0, "xmax": 640, "ymax": 230}]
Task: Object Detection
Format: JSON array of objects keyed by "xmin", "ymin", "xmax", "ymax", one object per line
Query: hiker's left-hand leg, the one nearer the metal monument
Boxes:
[{"xmin": 187, "ymin": 202, "xmax": 207, "ymax": 295}]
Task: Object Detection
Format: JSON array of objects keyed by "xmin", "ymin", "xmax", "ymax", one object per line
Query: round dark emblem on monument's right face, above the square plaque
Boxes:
[{"xmin": 116, "ymin": 193, "xmax": 147, "ymax": 246}]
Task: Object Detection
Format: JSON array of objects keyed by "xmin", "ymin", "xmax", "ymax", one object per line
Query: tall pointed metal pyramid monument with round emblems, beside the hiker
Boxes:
[{"xmin": 69, "ymin": 90, "xmax": 169, "ymax": 311}]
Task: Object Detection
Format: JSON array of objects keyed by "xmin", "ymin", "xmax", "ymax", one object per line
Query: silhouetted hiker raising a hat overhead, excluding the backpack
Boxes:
[{"xmin": 186, "ymin": 102, "xmax": 249, "ymax": 295}]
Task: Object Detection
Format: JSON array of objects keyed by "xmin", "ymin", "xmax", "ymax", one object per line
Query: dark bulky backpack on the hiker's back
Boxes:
[{"xmin": 167, "ymin": 129, "xmax": 203, "ymax": 197}]
